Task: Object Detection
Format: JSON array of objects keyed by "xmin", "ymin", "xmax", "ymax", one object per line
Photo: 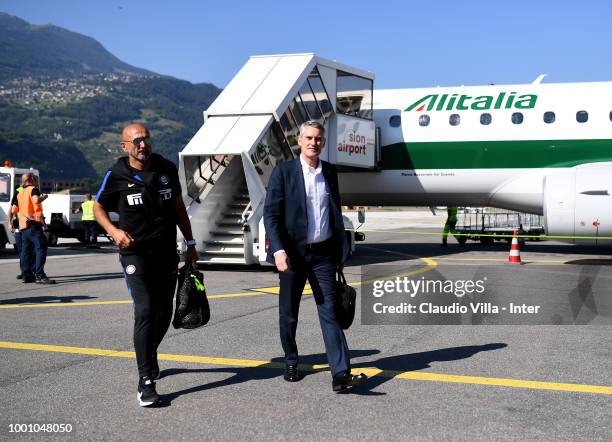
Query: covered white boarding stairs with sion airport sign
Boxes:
[{"xmin": 179, "ymin": 54, "xmax": 376, "ymax": 265}]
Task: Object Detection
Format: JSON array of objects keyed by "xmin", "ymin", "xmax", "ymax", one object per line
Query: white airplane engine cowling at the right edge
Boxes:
[{"xmin": 544, "ymin": 163, "xmax": 612, "ymax": 245}]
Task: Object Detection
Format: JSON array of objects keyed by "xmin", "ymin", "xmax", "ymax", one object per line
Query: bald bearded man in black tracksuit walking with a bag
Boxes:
[{"xmin": 94, "ymin": 124, "xmax": 197, "ymax": 406}]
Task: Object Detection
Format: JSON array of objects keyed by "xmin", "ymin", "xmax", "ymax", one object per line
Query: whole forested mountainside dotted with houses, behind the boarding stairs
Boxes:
[{"xmin": 0, "ymin": 13, "xmax": 221, "ymax": 185}]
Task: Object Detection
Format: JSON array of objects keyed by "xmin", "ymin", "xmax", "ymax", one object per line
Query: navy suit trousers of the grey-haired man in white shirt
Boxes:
[{"xmin": 279, "ymin": 244, "xmax": 350, "ymax": 376}]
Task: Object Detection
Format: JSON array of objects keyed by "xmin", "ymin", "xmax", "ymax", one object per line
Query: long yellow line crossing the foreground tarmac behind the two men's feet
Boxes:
[{"xmin": 0, "ymin": 341, "xmax": 612, "ymax": 395}]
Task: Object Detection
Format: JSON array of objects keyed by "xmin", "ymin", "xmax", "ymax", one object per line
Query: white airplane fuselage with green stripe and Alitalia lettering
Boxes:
[{"xmin": 340, "ymin": 82, "xmax": 612, "ymax": 213}]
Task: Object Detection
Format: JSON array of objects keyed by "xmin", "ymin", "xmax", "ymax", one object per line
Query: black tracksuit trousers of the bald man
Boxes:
[{"xmin": 120, "ymin": 251, "xmax": 178, "ymax": 377}]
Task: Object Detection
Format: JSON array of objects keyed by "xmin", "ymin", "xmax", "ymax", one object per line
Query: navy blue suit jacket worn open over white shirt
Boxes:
[{"xmin": 264, "ymin": 157, "xmax": 349, "ymax": 264}]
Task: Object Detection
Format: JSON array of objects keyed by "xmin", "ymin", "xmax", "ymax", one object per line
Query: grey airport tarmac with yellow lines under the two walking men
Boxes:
[{"xmin": 0, "ymin": 212, "xmax": 612, "ymax": 440}]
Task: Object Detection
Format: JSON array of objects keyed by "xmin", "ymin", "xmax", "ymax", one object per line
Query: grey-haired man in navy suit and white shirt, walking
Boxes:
[{"xmin": 264, "ymin": 121, "xmax": 366, "ymax": 392}]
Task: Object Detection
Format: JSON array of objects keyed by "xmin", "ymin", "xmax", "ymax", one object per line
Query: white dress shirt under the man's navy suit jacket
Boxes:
[{"xmin": 300, "ymin": 155, "xmax": 331, "ymax": 244}]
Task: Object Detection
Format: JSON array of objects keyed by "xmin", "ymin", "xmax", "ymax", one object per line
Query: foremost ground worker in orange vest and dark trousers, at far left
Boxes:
[{"xmin": 17, "ymin": 173, "xmax": 55, "ymax": 284}]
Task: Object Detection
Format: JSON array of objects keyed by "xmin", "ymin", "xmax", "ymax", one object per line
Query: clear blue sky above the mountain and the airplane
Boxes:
[{"xmin": 0, "ymin": 0, "xmax": 612, "ymax": 88}]
